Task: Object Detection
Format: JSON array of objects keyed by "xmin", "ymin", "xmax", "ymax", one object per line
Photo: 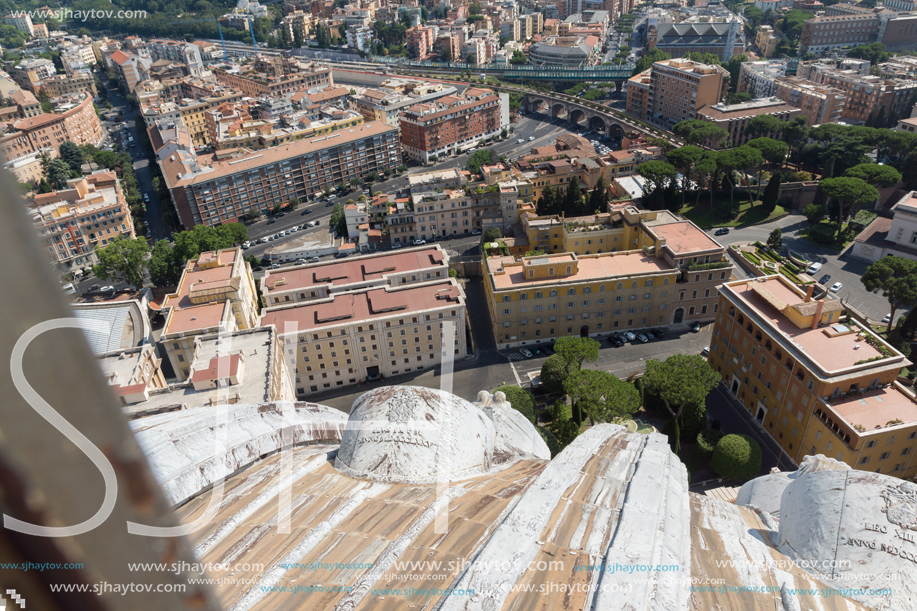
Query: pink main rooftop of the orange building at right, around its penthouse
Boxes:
[{"xmin": 722, "ymin": 276, "xmax": 904, "ymax": 374}]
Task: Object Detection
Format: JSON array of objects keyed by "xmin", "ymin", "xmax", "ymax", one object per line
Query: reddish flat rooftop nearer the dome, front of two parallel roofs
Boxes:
[{"xmin": 261, "ymin": 281, "xmax": 464, "ymax": 330}]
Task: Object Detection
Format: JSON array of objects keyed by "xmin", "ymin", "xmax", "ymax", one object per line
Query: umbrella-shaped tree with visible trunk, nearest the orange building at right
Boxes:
[{"xmin": 642, "ymin": 354, "xmax": 720, "ymax": 452}]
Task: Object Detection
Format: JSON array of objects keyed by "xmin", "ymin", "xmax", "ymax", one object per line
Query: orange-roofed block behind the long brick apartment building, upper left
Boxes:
[{"xmin": 213, "ymin": 56, "xmax": 334, "ymax": 98}]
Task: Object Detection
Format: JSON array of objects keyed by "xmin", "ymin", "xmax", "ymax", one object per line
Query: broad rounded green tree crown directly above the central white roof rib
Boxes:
[{"xmin": 564, "ymin": 369, "xmax": 640, "ymax": 423}]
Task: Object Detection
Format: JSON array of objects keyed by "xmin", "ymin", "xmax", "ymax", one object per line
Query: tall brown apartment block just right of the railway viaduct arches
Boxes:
[{"xmin": 626, "ymin": 59, "xmax": 729, "ymax": 128}]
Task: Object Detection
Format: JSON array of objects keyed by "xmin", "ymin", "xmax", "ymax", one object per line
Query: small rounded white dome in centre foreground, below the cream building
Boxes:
[{"xmin": 334, "ymin": 386, "xmax": 494, "ymax": 484}]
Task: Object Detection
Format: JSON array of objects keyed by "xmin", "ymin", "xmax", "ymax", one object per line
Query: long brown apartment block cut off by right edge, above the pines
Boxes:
[{"xmin": 812, "ymin": 70, "xmax": 917, "ymax": 122}]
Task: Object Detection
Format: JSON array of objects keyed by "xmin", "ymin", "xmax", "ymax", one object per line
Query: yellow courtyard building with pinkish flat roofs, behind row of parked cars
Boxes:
[{"xmin": 484, "ymin": 206, "xmax": 732, "ymax": 349}]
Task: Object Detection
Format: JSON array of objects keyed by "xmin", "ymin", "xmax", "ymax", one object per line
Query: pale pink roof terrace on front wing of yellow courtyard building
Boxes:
[{"xmin": 487, "ymin": 250, "xmax": 674, "ymax": 290}]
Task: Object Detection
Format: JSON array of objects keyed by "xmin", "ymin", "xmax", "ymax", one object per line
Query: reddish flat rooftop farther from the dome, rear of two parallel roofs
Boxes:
[{"xmin": 264, "ymin": 245, "xmax": 446, "ymax": 294}]
